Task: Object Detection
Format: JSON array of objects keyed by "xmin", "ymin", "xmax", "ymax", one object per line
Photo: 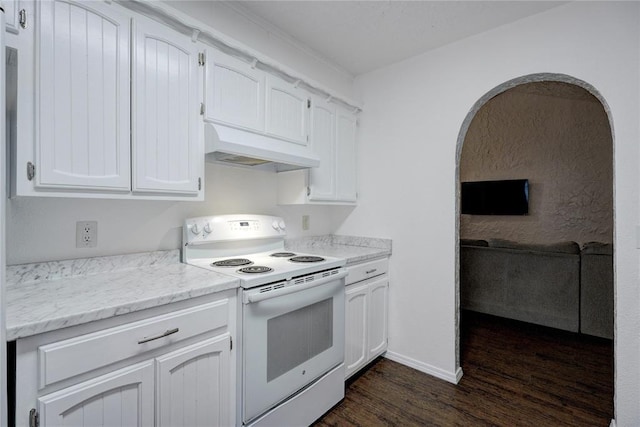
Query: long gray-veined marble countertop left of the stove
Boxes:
[{"xmin": 6, "ymin": 250, "xmax": 239, "ymax": 341}]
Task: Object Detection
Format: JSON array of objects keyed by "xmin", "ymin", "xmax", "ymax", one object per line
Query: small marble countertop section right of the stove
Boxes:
[{"xmin": 285, "ymin": 235, "xmax": 391, "ymax": 265}]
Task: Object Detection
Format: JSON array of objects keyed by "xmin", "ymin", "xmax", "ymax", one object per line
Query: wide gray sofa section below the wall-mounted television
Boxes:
[{"xmin": 460, "ymin": 239, "xmax": 581, "ymax": 332}]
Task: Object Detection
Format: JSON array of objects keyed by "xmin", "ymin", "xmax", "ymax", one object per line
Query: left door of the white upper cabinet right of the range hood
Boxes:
[{"xmin": 309, "ymin": 98, "xmax": 336, "ymax": 201}]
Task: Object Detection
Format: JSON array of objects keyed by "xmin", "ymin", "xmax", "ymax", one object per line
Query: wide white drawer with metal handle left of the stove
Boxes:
[{"xmin": 38, "ymin": 299, "xmax": 229, "ymax": 389}]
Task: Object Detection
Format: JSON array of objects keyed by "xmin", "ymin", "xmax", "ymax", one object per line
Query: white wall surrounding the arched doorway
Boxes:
[{"xmin": 344, "ymin": 2, "xmax": 640, "ymax": 426}]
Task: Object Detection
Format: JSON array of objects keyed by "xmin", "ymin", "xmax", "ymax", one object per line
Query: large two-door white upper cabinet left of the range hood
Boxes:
[{"xmin": 6, "ymin": 0, "xmax": 204, "ymax": 200}]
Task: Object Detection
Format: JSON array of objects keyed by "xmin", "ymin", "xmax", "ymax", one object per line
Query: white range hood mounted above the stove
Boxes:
[{"xmin": 204, "ymin": 123, "xmax": 320, "ymax": 172}]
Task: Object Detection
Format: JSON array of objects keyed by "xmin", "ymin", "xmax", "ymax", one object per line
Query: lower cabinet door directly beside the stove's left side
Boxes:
[{"xmin": 156, "ymin": 333, "xmax": 233, "ymax": 427}]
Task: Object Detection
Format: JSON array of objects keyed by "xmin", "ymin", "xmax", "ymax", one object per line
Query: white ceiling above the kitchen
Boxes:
[{"xmin": 225, "ymin": 0, "xmax": 567, "ymax": 76}]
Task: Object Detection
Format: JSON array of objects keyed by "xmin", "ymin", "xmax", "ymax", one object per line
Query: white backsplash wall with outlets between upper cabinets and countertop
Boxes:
[{"xmin": 7, "ymin": 164, "xmax": 340, "ymax": 265}]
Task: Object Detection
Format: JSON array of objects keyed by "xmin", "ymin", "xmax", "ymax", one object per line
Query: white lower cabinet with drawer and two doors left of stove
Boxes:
[{"xmin": 15, "ymin": 290, "xmax": 237, "ymax": 427}]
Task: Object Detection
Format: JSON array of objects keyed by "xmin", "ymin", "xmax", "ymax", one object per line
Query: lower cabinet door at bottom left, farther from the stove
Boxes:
[{"xmin": 38, "ymin": 361, "xmax": 154, "ymax": 427}]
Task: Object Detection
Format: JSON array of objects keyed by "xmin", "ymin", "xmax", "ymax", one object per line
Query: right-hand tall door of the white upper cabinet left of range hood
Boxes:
[{"xmin": 132, "ymin": 18, "xmax": 204, "ymax": 195}]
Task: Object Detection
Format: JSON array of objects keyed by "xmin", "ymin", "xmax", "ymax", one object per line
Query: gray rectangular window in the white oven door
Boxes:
[{"xmin": 267, "ymin": 298, "xmax": 333, "ymax": 382}]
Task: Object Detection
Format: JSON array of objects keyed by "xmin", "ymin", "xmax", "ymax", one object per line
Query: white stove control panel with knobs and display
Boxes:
[{"xmin": 182, "ymin": 215, "xmax": 287, "ymax": 246}]
